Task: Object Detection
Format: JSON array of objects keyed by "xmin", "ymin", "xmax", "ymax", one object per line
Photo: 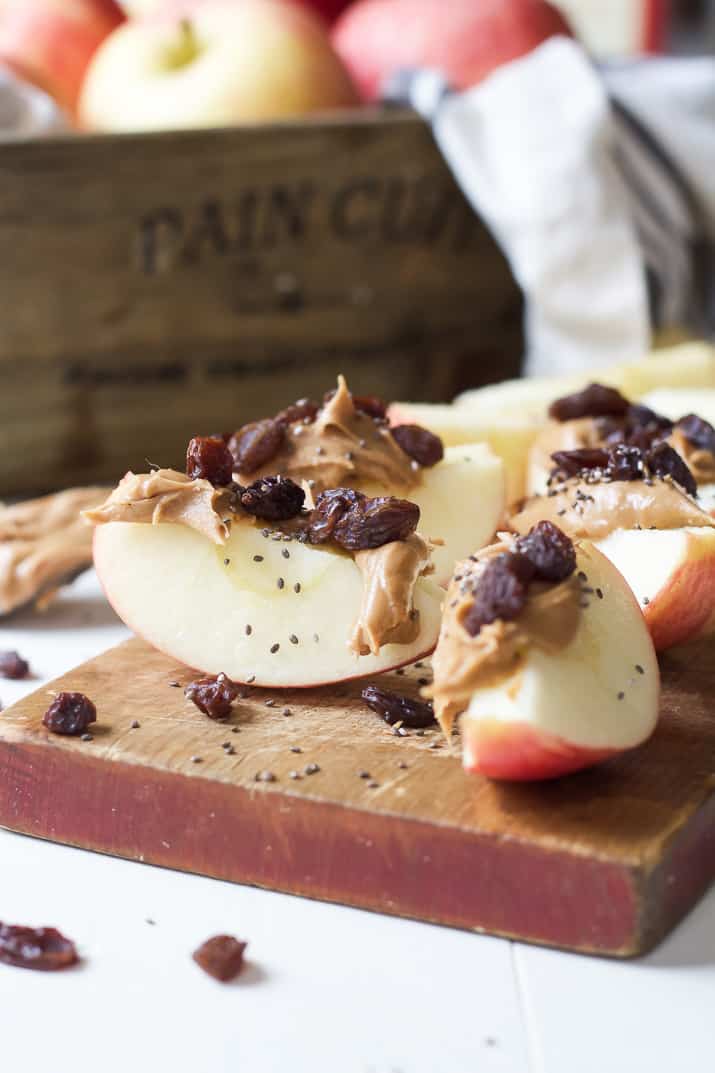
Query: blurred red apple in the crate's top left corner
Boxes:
[{"xmin": 0, "ymin": 0, "xmax": 126, "ymax": 116}]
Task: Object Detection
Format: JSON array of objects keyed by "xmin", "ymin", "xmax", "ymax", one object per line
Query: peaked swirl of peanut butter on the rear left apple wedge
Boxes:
[{"xmin": 237, "ymin": 377, "xmax": 420, "ymax": 495}]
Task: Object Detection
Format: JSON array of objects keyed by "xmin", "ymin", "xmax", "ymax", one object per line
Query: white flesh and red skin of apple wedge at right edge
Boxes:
[{"xmin": 598, "ymin": 527, "xmax": 715, "ymax": 651}]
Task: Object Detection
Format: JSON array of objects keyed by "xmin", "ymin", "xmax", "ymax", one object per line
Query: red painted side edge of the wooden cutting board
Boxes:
[{"xmin": 0, "ymin": 743, "xmax": 713, "ymax": 957}]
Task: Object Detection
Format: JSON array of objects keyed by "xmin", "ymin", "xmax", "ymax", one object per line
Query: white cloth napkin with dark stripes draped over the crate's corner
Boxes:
[{"xmin": 388, "ymin": 38, "xmax": 715, "ymax": 374}]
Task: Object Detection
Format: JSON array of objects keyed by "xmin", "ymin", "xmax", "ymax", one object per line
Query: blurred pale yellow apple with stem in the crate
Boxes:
[{"xmin": 79, "ymin": 0, "xmax": 358, "ymax": 131}]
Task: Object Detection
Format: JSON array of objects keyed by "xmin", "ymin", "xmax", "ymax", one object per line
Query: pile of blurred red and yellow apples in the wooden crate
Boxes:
[{"xmin": 0, "ymin": 0, "xmax": 569, "ymax": 131}]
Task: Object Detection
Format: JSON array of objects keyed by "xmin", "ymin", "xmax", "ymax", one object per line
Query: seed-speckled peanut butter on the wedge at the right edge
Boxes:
[{"xmin": 509, "ymin": 477, "xmax": 715, "ymax": 540}]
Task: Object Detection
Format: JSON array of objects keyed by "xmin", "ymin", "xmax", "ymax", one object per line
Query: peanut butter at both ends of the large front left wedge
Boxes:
[{"xmin": 83, "ymin": 463, "xmax": 432, "ymax": 656}]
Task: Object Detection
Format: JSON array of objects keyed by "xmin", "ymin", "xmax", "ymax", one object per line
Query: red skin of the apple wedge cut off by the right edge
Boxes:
[{"xmin": 642, "ymin": 542, "xmax": 715, "ymax": 652}]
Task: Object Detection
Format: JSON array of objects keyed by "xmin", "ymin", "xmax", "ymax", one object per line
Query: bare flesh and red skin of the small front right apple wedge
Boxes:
[{"xmin": 457, "ymin": 542, "xmax": 659, "ymax": 781}]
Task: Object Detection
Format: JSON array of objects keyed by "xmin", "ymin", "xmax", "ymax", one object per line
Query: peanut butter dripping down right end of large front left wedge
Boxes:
[{"xmin": 350, "ymin": 533, "xmax": 432, "ymax": 656}]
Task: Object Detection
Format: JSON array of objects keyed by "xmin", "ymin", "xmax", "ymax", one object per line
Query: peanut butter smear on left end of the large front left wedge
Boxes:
[{"xmin": 84, "ymin": 469, "xmax": 231, "ymax": 544}]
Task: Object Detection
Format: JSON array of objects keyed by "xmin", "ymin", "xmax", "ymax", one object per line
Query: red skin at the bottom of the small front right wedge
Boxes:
[{"xmin": 462, "ymin": 717, "xmax": 622, "ymax": 782}]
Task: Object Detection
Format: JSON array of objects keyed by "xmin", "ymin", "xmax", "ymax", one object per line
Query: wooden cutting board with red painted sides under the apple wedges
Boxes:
[{"xmin": 0, "ymin": 641, "xmax": 715, "ymax": 957}]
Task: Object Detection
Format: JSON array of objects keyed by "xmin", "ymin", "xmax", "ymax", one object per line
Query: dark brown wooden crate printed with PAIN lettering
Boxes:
[{"xmin": 0, "ymin": 112, "xmax": 522, "ymax": 495}]
